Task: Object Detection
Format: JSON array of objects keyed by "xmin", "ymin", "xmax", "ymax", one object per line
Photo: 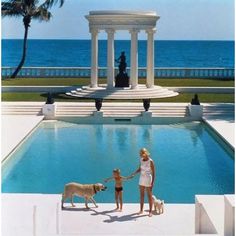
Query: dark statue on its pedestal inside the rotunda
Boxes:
[{"xmin": 115, "ymin": 51, "xmax": 129, "ymax": 87}]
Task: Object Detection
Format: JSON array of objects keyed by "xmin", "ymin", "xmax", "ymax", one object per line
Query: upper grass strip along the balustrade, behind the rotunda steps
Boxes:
[{"xmin": 2, "ymin": 78, "xmax": 234, "ymax": 87}]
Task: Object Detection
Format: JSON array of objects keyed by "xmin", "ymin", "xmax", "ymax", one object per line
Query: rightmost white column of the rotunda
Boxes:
[{"xmin": 146, "ymin": 29, "xmax": 155, "ymax": 88}]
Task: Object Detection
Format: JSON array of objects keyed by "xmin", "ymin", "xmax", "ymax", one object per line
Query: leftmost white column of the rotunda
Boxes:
[{"xmin": 90, "ymin": 29, "xmax": 98, "ymax": 88}]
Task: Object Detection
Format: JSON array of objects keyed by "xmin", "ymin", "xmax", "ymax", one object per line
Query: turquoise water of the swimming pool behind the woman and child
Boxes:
[{"xmin": 2, "ymin": 121, "xmax": 234, "ymax": 203}]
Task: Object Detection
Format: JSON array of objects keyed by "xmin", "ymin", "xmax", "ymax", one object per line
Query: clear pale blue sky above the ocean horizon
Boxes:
[{"xmin": 2, "ymin": 0, "xmax": 234, "ymax": 40}]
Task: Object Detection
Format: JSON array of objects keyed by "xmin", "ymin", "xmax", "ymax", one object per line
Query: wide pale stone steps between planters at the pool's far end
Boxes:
[{"xmin": 2, "ymin": 102, "xmax": 234, "ymax": 118}]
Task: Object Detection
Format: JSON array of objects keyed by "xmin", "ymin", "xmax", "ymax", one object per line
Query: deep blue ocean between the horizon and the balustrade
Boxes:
[{"xmin": 2, "ymin": 39, "xmax": 234, "ymax": 68}]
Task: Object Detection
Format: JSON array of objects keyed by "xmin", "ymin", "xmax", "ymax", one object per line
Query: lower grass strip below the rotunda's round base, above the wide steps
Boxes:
[{"xmin": 2, "ymin": 93, "xmax": 234, "ymax": 103}]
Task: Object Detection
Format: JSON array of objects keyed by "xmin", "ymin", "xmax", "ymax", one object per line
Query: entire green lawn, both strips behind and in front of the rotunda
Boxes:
[{"xmin": 2, "ymin": 78, "xmax": 234, "ymax": 103}]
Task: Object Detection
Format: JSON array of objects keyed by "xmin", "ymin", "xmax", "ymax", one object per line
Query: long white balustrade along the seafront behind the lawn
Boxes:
[{"xmin": 2, "ymin": 67, "xmax": 234, "ymax": 79}]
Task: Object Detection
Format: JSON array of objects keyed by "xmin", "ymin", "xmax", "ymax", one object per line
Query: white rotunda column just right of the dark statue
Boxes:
[{"xmin": 130, "ymin": 29, "xmax": 139, "ymax": 89}]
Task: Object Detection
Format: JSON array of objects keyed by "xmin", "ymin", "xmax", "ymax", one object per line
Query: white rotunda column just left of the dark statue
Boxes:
[{"xmin": 106, "ymin": 29, "xmax": 115, "ymax": 88}]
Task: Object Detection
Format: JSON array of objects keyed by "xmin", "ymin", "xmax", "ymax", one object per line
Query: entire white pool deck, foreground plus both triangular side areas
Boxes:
[{"xmin": 1, "ymin": 102, "xmax": 235, "ymax": 236}]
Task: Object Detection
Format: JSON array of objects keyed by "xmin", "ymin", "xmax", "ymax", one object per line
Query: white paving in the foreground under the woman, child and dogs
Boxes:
[{"xmin": 2, "ymin": 193, "xmax": 195, "ymax": 236}]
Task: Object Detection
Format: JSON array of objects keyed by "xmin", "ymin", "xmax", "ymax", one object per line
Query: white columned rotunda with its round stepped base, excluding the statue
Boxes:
[{"xmin": 67, "ymin": 11, "xmax": 178, "ymax": 99}]
